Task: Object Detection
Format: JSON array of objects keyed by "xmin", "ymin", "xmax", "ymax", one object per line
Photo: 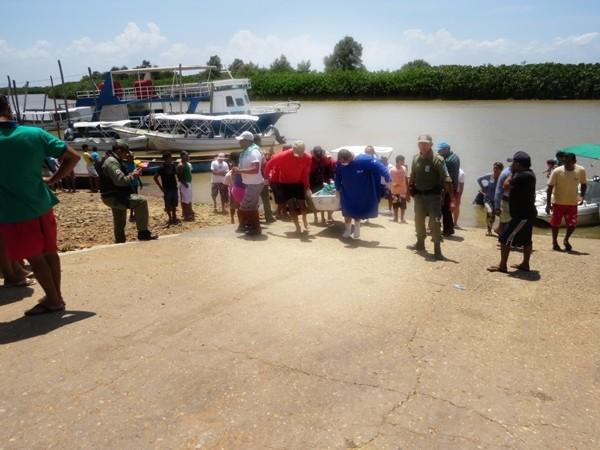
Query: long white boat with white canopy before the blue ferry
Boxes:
[{"xmin": 112, "ymin": 114, "xmax": 277, "ymax": 154}]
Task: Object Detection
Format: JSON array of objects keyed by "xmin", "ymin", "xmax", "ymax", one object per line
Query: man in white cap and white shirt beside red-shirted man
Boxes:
[{"xmin": 232, "ymin": 131, "xmax": 264, "ymax": 236}]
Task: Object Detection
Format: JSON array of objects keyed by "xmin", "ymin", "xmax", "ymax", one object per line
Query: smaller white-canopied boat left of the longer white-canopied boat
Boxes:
[{"xmin": 65, "ymin": 120, "xmax": 148, "ymax": 151}]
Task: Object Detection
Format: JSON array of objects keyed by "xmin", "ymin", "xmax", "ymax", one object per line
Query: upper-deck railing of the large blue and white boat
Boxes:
[{"xmin": 77, "ymin": 79, "xmax": 250, "ymax": 101}]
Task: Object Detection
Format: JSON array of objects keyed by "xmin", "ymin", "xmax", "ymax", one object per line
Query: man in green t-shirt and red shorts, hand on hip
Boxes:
[{"xmin": 0, "ymin": 95, "xmax": 79, "ymax": 316}]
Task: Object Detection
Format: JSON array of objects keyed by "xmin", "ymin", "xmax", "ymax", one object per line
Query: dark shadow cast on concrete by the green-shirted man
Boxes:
[{"xmin": 0, "ymin": 311, "xmax": 96, "ymax": 345}]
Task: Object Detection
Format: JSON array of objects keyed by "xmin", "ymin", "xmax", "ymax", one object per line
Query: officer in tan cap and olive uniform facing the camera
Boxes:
[{"xmin": 408, "ymin": 134, "xmax": 453, "ymax": 260}]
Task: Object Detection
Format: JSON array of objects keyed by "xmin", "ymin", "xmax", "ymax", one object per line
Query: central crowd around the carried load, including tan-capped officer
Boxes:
[{"xmin": 223, "ymin": 132, "xmax": 464, "ymax": 259}]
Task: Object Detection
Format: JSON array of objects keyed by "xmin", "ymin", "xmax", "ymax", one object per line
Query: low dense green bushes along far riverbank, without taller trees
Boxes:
[{"xmin": 10, "ymin": 63, "xmax": 600, "ymax": 100}]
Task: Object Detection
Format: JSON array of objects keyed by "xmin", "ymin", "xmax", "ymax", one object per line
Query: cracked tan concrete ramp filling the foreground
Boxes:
[{"xmin": 0, "ymin": 217, "xmax": 600, "ymax": 449}]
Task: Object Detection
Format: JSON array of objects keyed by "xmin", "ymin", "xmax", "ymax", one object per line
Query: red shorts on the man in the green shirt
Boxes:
[{"xmin": 0, "ymin": 209, "xmax": 58, "ymax": 261}]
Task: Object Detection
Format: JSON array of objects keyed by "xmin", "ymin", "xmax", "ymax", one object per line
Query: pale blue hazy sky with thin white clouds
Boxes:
[{"xmin": 0, "ymin": 0, "xmax": 600, "ymax": 85}]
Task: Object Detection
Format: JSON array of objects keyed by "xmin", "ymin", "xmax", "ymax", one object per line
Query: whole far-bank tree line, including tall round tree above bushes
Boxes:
[{"xmin": 4, "ymin": 36, "xmax": 600, "ymax": 100}]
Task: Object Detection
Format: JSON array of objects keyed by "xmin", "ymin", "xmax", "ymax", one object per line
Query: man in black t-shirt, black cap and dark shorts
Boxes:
[{"xmin": 487, "ymin": 151, "xmax": 537, "ymax": 273}]
